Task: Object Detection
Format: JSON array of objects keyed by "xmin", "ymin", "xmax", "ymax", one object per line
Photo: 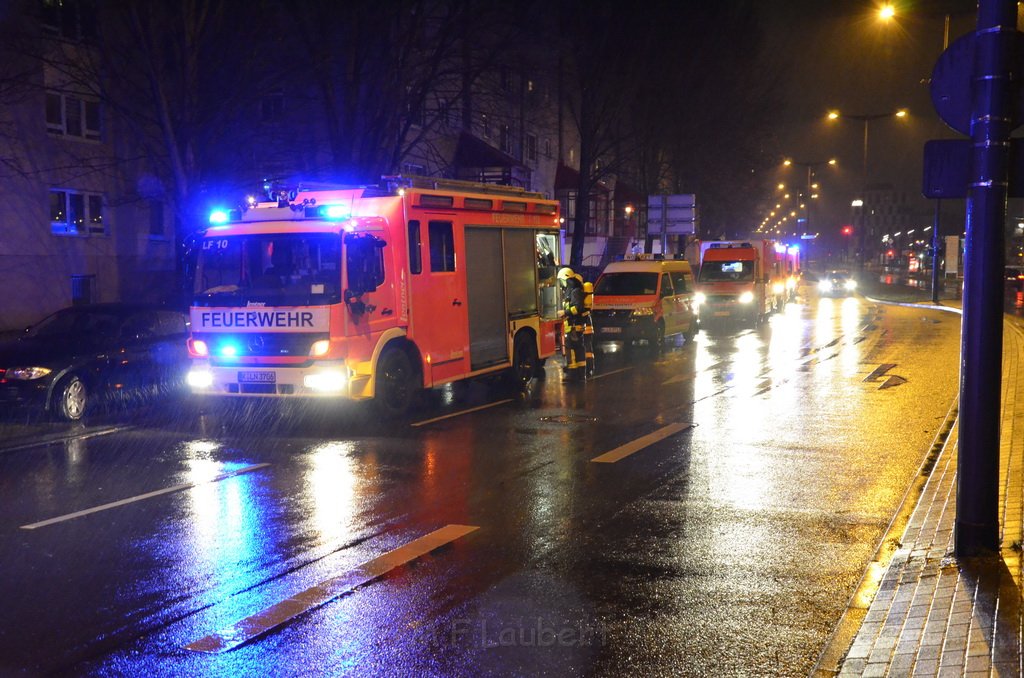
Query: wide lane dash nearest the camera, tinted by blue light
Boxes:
[{"xmin": 185, "ymin": 524, "xmax": 479, "ymax": 654}]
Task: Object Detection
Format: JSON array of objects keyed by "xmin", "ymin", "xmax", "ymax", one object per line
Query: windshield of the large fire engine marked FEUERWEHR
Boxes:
[{"xmin": 194, "ymin": 234, "xmax": 341, "ymax": 306}]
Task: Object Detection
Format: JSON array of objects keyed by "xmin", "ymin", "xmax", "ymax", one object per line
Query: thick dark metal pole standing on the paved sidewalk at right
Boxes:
[{"xmin": 953, "ymin": 0, "xmax": 1018, "ymax": 557}]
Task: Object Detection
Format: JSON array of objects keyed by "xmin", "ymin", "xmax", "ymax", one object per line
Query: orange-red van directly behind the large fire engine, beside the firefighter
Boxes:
[{"xmin": 592, "ymin": 255, "xmax": 697, "ymax": 349}]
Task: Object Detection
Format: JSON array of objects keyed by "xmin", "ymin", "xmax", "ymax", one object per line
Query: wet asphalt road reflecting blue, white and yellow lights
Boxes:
[{"xmin": 0, "ymin": 284, "xmax": 959, "ymax": 676}]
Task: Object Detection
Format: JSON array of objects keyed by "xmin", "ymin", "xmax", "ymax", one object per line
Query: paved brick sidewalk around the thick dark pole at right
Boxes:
[{"xmin": 813, "ymin": 278, "xmax": 1024, "ymax": 676}]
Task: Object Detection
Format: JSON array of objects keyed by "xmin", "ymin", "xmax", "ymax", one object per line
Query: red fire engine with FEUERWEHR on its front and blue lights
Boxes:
[{"xmin": 188, "ymin": 176, "xmax": 560, "ymax": 414}]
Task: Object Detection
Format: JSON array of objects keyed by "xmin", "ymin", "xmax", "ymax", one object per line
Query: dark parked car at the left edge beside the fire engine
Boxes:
[{"xmin": 0, "ymin": 303, "xmax": 188, "ymax": 421}]
